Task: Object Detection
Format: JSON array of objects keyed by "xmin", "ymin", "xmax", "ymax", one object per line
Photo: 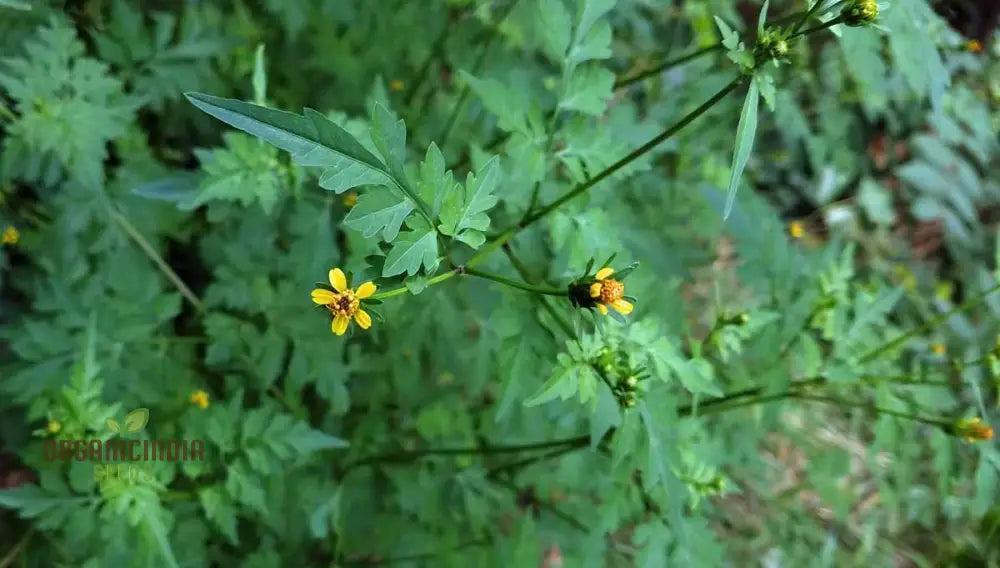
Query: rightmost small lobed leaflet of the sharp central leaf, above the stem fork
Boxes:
[{"xmin": 438, "ymin": 156, "xmax": 500, "ymax": 248}]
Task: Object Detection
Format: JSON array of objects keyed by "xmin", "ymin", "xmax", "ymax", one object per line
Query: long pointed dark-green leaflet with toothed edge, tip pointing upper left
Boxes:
[{"xmin": 185, "ymin": 93, "xmax": 392, "ymax": 191}]
